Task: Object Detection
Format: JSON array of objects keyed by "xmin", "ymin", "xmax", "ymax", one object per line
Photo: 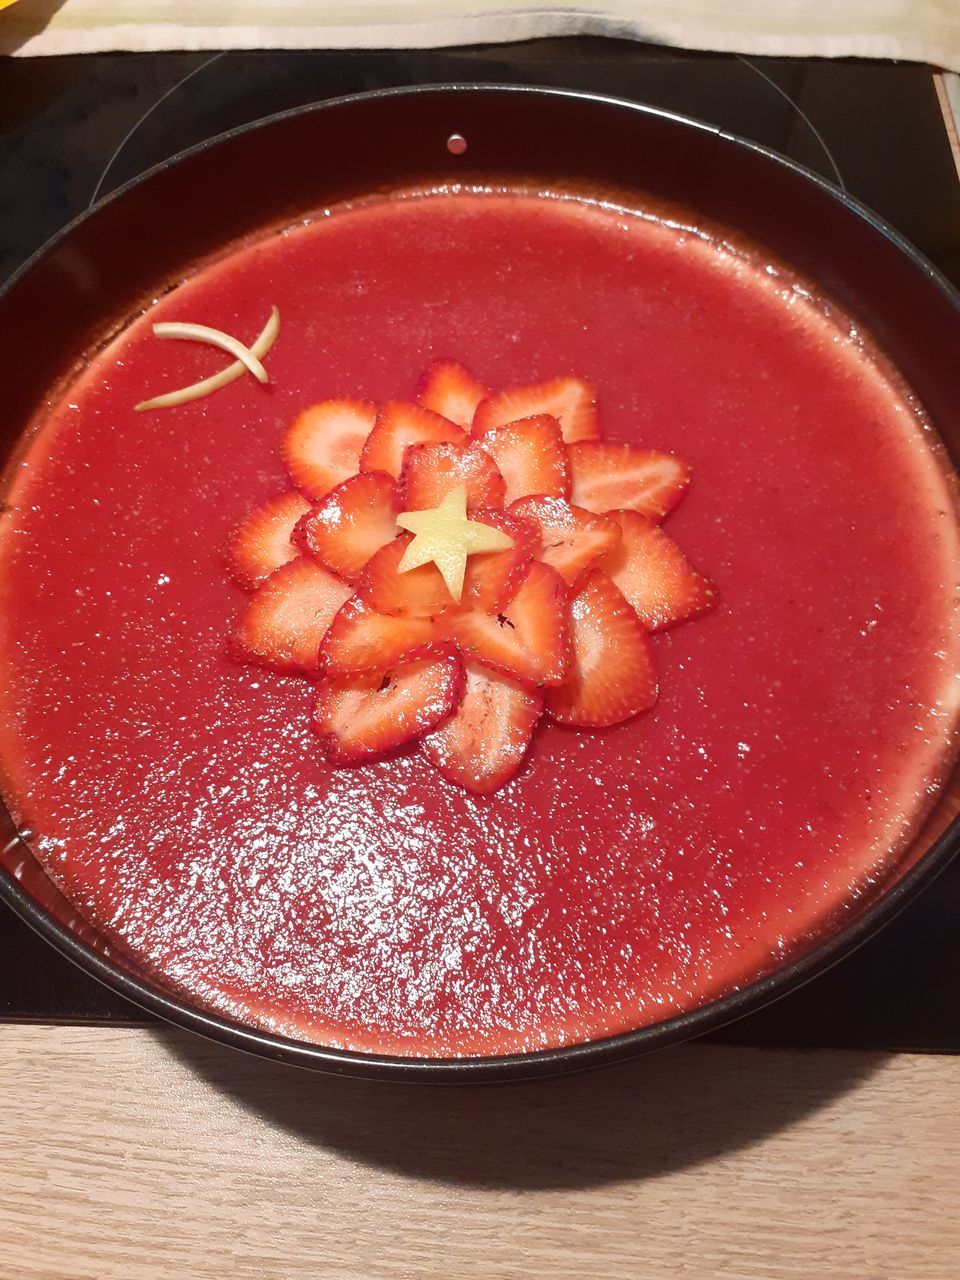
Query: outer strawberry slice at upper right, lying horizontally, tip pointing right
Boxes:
[{"xmin": 570, "ymin": 444, "xmax": 690, "ymax": 520}]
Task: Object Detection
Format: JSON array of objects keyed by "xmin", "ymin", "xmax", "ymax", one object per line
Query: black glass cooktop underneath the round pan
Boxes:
[{"xmin": 0, "ymin": 40, "xmax": 960, "ymax": 1052}]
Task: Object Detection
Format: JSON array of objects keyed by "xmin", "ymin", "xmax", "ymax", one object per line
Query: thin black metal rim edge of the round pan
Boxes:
[{"xmin": 0, "ymin": 83, "xmax": 960, "ymax": 1083}]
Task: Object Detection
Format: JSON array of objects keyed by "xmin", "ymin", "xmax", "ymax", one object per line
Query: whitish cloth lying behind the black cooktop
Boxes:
[{"xmin": 0, "ymin": 0, "xmax": 960, "ymax": 70}]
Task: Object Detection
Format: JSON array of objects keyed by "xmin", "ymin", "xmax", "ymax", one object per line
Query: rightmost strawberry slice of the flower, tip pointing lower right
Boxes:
[{"xmin": 602, "ymin": 511, "xmax": 717, "ymax": 631}]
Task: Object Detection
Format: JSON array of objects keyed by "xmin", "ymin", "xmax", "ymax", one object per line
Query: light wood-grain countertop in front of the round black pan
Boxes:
[{"xmin": 0, "ymin": 1025, "xmax": 960, "ymax": 1280}]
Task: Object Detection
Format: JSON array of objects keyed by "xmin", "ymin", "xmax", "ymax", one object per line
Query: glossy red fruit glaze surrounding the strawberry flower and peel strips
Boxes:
[{"xmin": 0, "ymin": 192, "xmax": 957, "ymax": 1055}]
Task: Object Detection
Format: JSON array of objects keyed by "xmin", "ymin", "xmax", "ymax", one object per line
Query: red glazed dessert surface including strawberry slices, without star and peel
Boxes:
[{"xmin": 0, "ymin": 192, "xmax": 957, "ymax": 1056}]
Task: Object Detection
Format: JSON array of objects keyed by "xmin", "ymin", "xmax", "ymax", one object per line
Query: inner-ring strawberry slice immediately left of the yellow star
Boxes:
[{"xmin": 296, "ymin": 471, "xmax": 397, "ymax": 581}]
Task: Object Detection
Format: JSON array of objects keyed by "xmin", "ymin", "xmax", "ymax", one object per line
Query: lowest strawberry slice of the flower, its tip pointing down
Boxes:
[{"xmin": 424, "ymin": 663, "xmax": 543, "ymax": 795}]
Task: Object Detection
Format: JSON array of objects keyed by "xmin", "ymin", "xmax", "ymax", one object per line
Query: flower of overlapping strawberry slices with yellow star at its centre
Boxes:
[{"xmin": 227, "ymin": 360, "xmax": 717, "ymax": 795}]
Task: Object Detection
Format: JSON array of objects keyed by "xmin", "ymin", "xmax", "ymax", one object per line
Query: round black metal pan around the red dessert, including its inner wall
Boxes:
[{"xmin": 0, "ymin": 86, "xmax": 960, "ymax": 1080}]
